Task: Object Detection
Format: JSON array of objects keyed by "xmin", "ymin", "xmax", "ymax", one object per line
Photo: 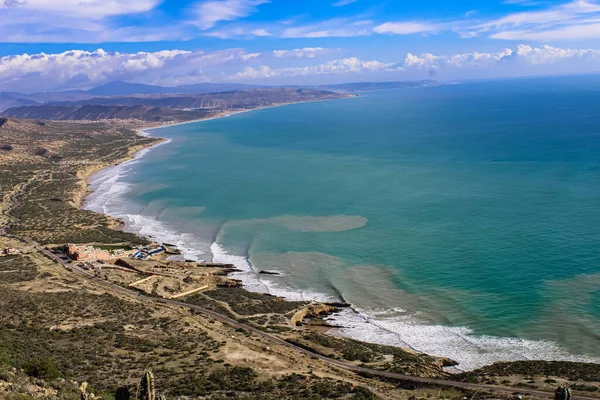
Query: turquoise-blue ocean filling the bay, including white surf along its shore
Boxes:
[{"xmin": 87, "ymin": 76, "xmax": 600, "ymax": 370}]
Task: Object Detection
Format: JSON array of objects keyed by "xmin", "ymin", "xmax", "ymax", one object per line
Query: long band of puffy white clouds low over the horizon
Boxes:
[{"xmin": 0, "ymin": 44, "xmax": 600, "ymax": 92}]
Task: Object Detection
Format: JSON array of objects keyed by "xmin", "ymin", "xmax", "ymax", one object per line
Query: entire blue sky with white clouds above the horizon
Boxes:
[{"xmin": 0, "ymin": 0, "xmax": 600, "ymax": 92}]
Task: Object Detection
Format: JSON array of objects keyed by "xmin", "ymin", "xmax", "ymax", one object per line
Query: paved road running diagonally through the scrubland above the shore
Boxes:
[{"xmin": 21, "ymin": 242, "xmax": 598, "ymax": 400}]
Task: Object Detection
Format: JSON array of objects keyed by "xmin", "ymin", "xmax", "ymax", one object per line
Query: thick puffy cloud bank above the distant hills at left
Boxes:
[{"xmin": 0, "ymin": 48, "xmax": 334, "ymax": 91}]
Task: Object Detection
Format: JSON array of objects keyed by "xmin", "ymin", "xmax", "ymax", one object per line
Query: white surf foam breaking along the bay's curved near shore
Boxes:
[{"xmin": 85, "ymin": 132, "xmax": 600, "ymax": 370}]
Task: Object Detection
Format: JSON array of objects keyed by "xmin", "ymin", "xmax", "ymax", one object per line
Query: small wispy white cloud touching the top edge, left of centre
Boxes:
[{"xmin": 195, "ymin": 0, "xmax": 269, "ymax": 29}]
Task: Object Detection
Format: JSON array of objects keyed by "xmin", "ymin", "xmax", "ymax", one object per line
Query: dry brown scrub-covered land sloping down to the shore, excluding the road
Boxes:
[{"xmin": 0, "ymin": 119, "xmax": 600, "ymax": 400}]
